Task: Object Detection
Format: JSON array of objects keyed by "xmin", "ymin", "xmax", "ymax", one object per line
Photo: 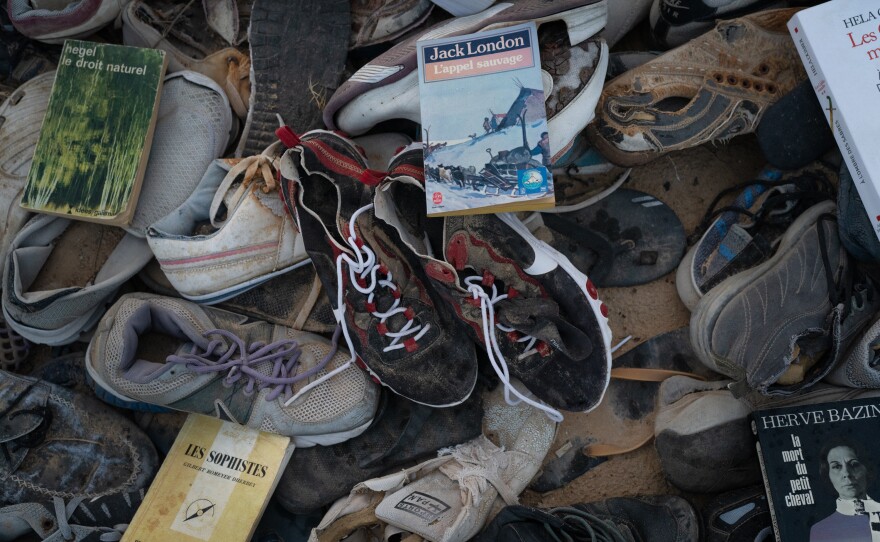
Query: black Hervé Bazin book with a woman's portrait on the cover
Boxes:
[{"xmin": 752, "ymin": 398, "xmax": 880, "ymax": 542}]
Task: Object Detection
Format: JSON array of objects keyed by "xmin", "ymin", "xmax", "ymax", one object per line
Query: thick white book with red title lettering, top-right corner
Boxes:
[{"xmin": 788, "ymin": 0, "xmax": 880, "ymax": 244}]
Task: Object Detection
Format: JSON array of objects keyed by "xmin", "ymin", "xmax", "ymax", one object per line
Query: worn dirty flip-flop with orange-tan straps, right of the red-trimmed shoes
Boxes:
[{"xmin": 529, "ymin": 327, "xmax": 723, "ymax": 493}]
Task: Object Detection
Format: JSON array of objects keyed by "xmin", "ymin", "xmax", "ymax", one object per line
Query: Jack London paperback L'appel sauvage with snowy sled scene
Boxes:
[{"xmin": 417, "ymin": 22, "xmax": 555, "ymax": 216}]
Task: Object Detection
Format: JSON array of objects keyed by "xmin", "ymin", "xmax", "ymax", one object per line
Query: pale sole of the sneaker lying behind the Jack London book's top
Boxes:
[{"xmin": 324, "ymin": 0, "xmax": 608, "ymax": 135}]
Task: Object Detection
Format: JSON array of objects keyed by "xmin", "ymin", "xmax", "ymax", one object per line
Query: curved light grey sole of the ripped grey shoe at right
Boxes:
[{"xmin": 691, "ymin": 201, "xmax": 837, "ymax": 374}]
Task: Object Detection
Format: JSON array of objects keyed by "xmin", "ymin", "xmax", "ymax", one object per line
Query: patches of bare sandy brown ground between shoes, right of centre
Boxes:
[{"xmin": 521, "ymin": 135, "xmax": 764, "ymax": 507}]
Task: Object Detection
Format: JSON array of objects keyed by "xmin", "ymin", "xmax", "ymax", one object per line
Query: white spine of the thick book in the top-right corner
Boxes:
[{"xmin": 788, "ymin": 14, "xmax": 880, "ymax": 244}]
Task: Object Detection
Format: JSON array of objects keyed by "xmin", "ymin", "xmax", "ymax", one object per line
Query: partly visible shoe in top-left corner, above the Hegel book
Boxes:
[{"xmin": 6, "ymin": 0, "xmax": 132, "ymax": 43}]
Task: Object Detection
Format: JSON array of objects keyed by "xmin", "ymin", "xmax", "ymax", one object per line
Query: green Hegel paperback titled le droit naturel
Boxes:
[{"xmin": 21, "ymin": 40, "xmax": 166, "ymax": 226}]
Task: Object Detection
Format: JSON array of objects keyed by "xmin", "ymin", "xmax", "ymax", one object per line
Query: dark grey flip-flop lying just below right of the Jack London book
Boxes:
[{"xmin": 529, "ymin": 188, "xmax": 687, "ymax": 288}]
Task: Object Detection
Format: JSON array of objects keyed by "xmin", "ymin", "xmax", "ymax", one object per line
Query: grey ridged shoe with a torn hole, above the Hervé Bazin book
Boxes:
[{"xmin": 691, "ymin": 201, "xmax": 880, "ymax": 395}]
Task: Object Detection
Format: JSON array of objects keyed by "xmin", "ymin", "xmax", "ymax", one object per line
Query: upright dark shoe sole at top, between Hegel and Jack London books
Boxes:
[{"xmin": 241, "ymin": 0, "xmax": 351, "ymax": 157}]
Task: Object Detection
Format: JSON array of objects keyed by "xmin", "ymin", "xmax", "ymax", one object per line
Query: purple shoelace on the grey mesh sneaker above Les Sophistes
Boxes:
[{"xmin": 166, "ymin": 327, "xmax": 339, "ymax": 401}]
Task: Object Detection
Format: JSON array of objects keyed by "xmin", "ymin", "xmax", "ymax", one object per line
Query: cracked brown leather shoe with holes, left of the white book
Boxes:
[{"xmin": 587, "ymin": 9, "xmax": 806, "ymax": 167}]
